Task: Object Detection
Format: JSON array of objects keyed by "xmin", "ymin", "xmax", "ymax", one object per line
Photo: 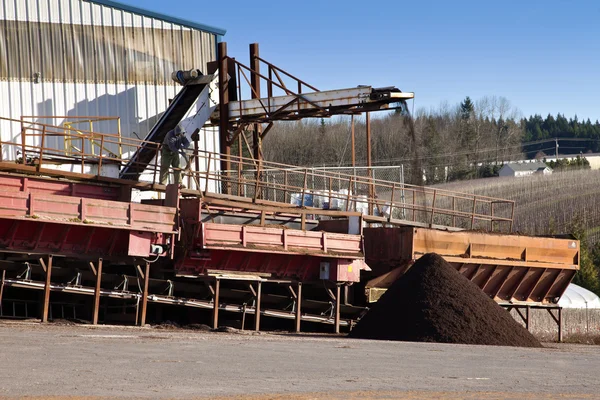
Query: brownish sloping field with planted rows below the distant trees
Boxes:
[{"xmin": 436, "ymin": 170, "xmax": 600, "ymax": 242}]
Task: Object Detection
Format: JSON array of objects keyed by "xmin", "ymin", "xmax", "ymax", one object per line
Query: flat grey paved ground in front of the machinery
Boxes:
[{"xmin": 0, "ymin": 321, "xmax": 600, "ymax": 400}]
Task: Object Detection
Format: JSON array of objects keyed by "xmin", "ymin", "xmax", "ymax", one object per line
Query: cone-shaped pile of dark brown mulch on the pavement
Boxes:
[{"xmin": 349, "ymin": 253, "xmax": 542, "ymax": 347}]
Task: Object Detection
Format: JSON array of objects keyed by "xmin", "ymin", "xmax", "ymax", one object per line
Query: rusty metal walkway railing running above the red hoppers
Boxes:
[{"xmin": 0, "ymin": 118, "xmax": 515, "ymax": 232}]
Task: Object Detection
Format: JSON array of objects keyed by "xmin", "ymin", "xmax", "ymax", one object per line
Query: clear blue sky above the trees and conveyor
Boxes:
[{"xmin": 120, "ymin": 0, "xmax": 600, "ymax": 120}]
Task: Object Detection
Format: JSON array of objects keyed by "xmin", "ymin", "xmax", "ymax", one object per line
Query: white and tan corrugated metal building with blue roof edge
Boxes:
[{"xmin": 0, "ymin": 0, "xmax": 225, "ymax": 159}]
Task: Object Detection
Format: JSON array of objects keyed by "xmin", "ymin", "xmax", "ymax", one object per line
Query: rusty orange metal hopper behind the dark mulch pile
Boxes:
[{"xmin": 364, "ymin": 227, "xmax": 580, "ymax": 305}]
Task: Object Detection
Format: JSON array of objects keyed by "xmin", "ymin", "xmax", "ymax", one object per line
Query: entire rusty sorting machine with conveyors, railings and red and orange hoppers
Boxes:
[{"xmin": 0, "ymin": 44, "xmax": 580, "ymax": 332}]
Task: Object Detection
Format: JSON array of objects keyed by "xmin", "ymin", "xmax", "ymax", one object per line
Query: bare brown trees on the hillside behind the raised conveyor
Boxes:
[{"xmin": 263, "ymin": 96, "xmax": 525, "ymax": 184}]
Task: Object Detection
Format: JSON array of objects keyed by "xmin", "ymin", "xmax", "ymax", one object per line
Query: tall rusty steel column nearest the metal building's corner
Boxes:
[{"xmin": 217, "ymin": 42, "xmax": 231, "ymax": 194}]
